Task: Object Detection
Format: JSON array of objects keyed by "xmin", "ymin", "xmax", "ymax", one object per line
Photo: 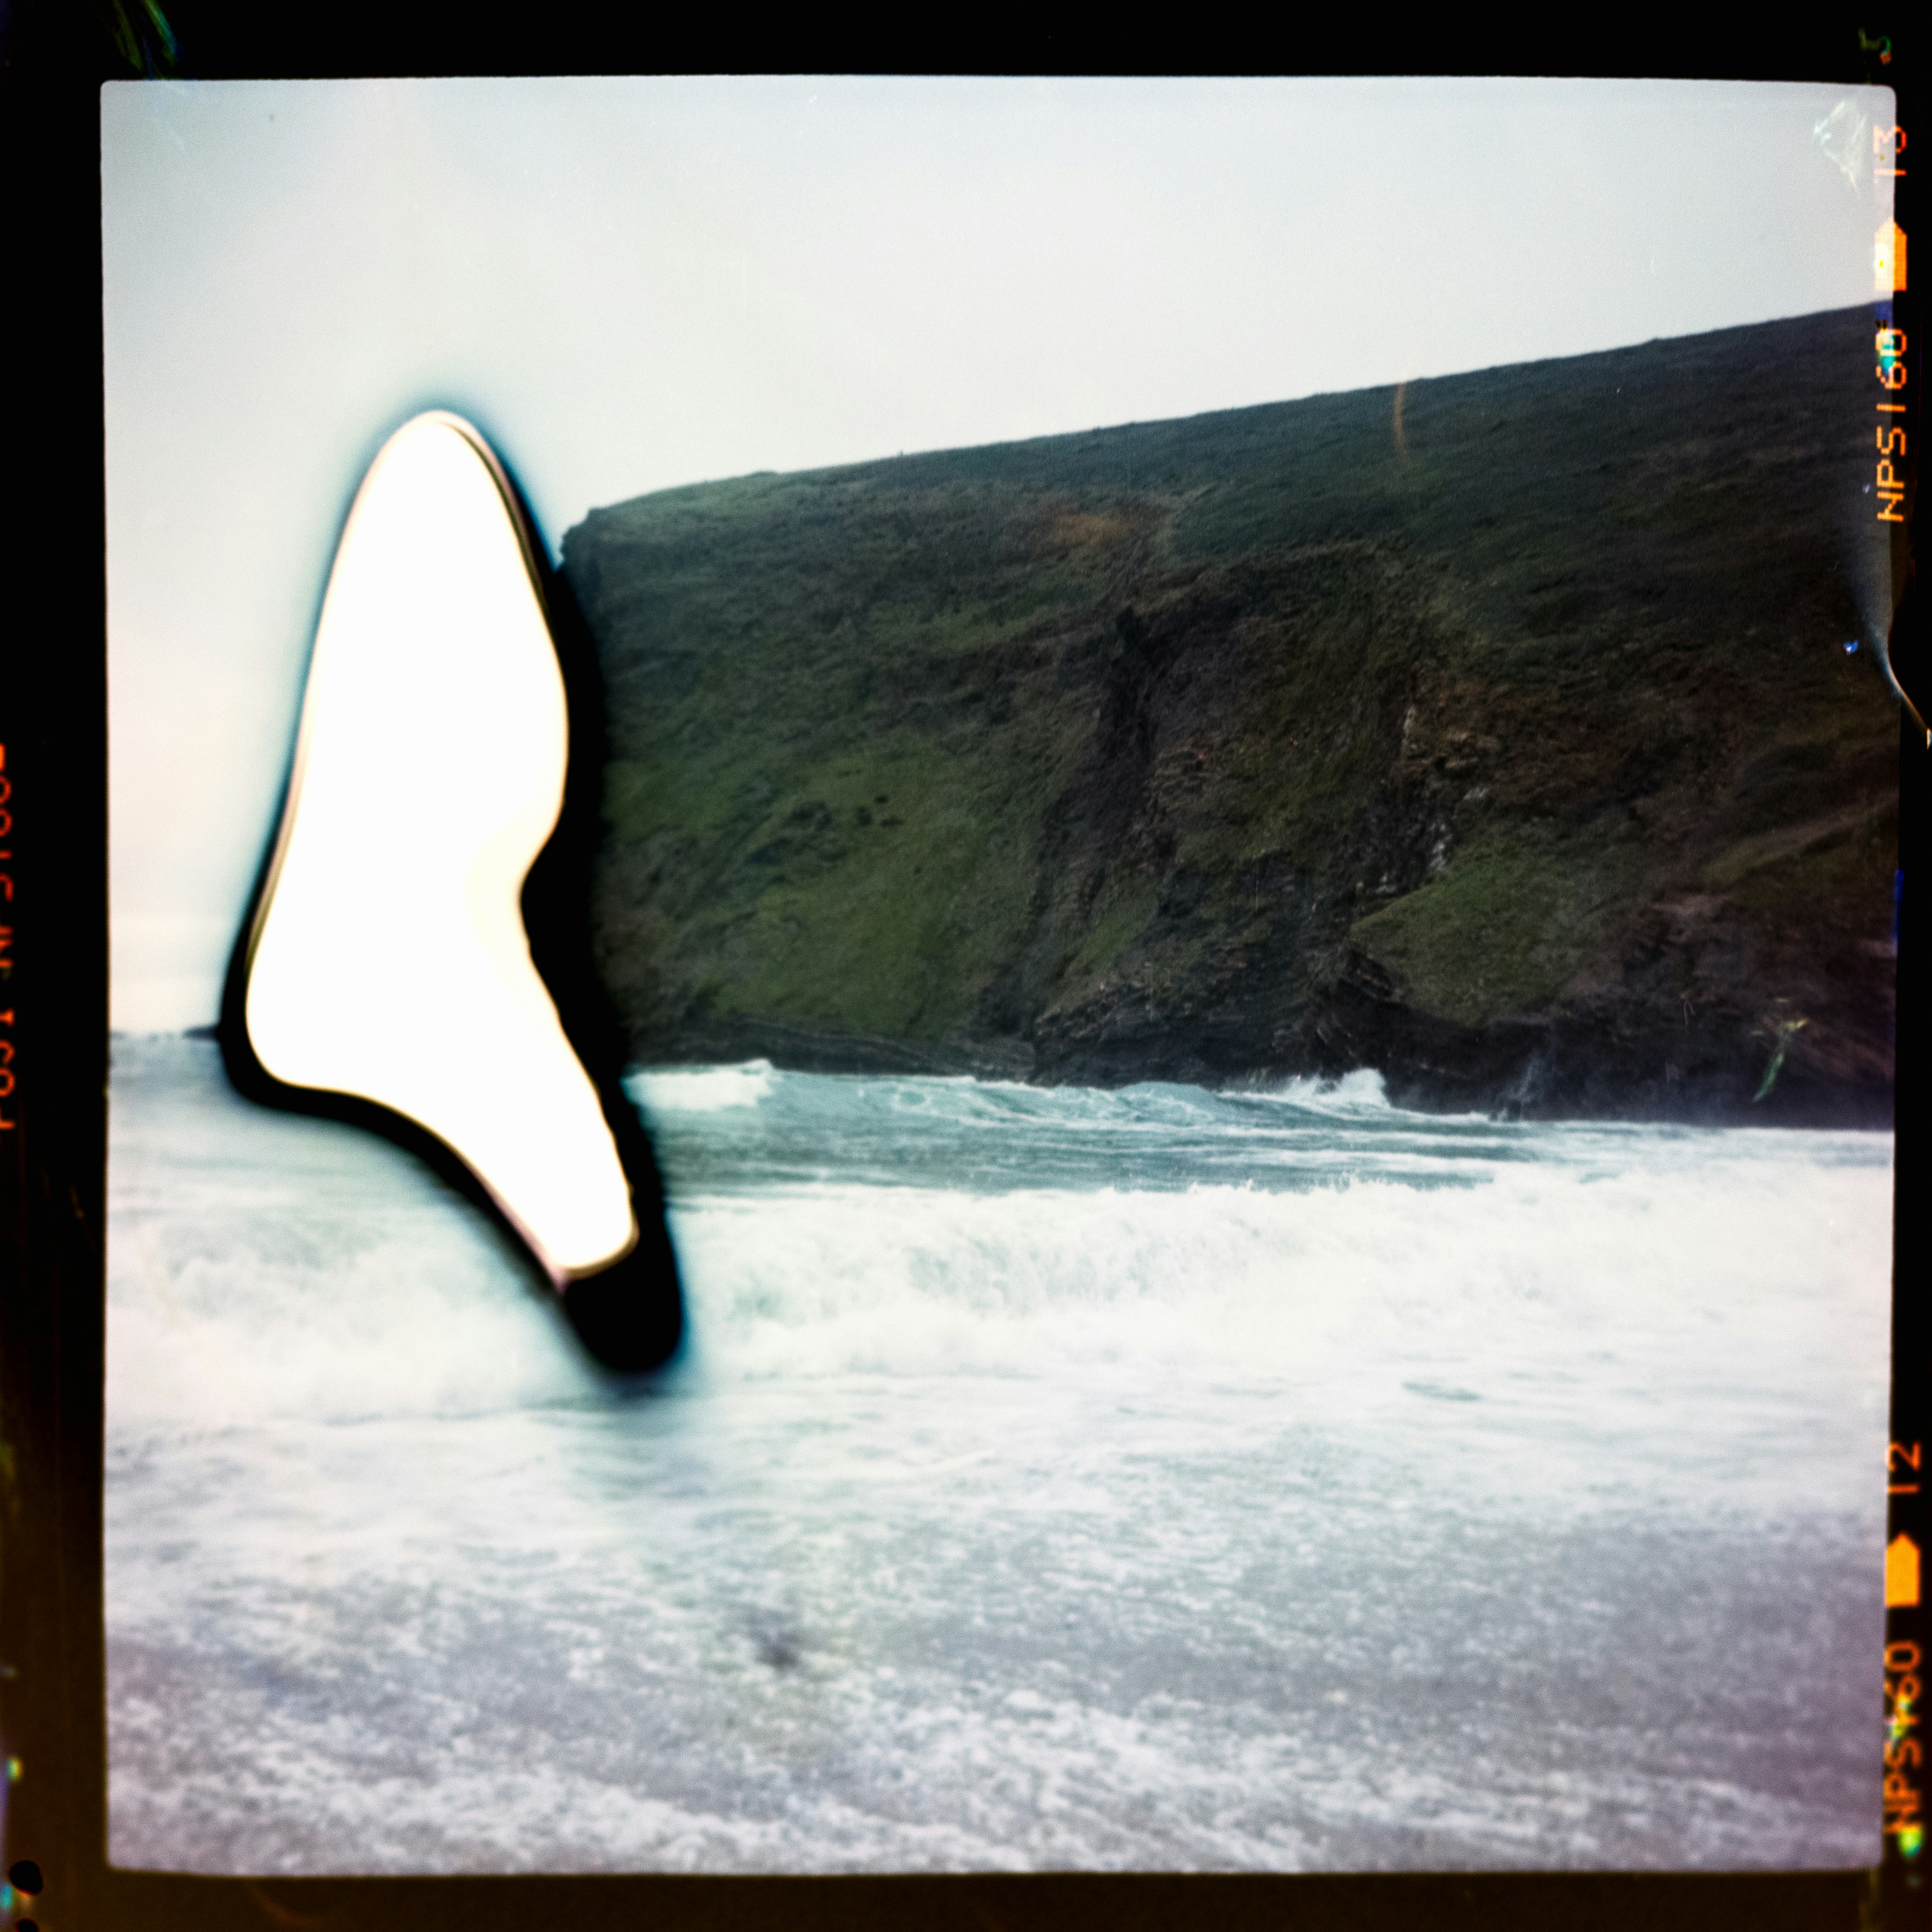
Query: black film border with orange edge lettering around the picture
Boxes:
[{"xmin": 0, "ymin": 15, "xmax": 1932, "ymax": 1932}]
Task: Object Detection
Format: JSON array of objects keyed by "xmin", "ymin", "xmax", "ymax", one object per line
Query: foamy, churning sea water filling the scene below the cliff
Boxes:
[{"xmin": 104, "ymin": 1038, "xmax": 1891, "ymax": 1874}]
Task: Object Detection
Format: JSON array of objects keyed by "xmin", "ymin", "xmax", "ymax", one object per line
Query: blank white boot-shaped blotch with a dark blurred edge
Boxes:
[{"xmin": 244, "ymin": 412, "xmax": 638, "ymax": 1287}]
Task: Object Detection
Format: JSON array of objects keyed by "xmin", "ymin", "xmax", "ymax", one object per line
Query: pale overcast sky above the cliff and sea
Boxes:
[{"xmin": 103, "ymin": 79, "xmax": 1891, "ymax": 1028}]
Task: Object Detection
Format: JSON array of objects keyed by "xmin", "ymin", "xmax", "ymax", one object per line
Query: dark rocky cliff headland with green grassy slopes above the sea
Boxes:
[{"xmin": 564, "ymin": 311, "xmax": 1899, "ymax": 1125}]
